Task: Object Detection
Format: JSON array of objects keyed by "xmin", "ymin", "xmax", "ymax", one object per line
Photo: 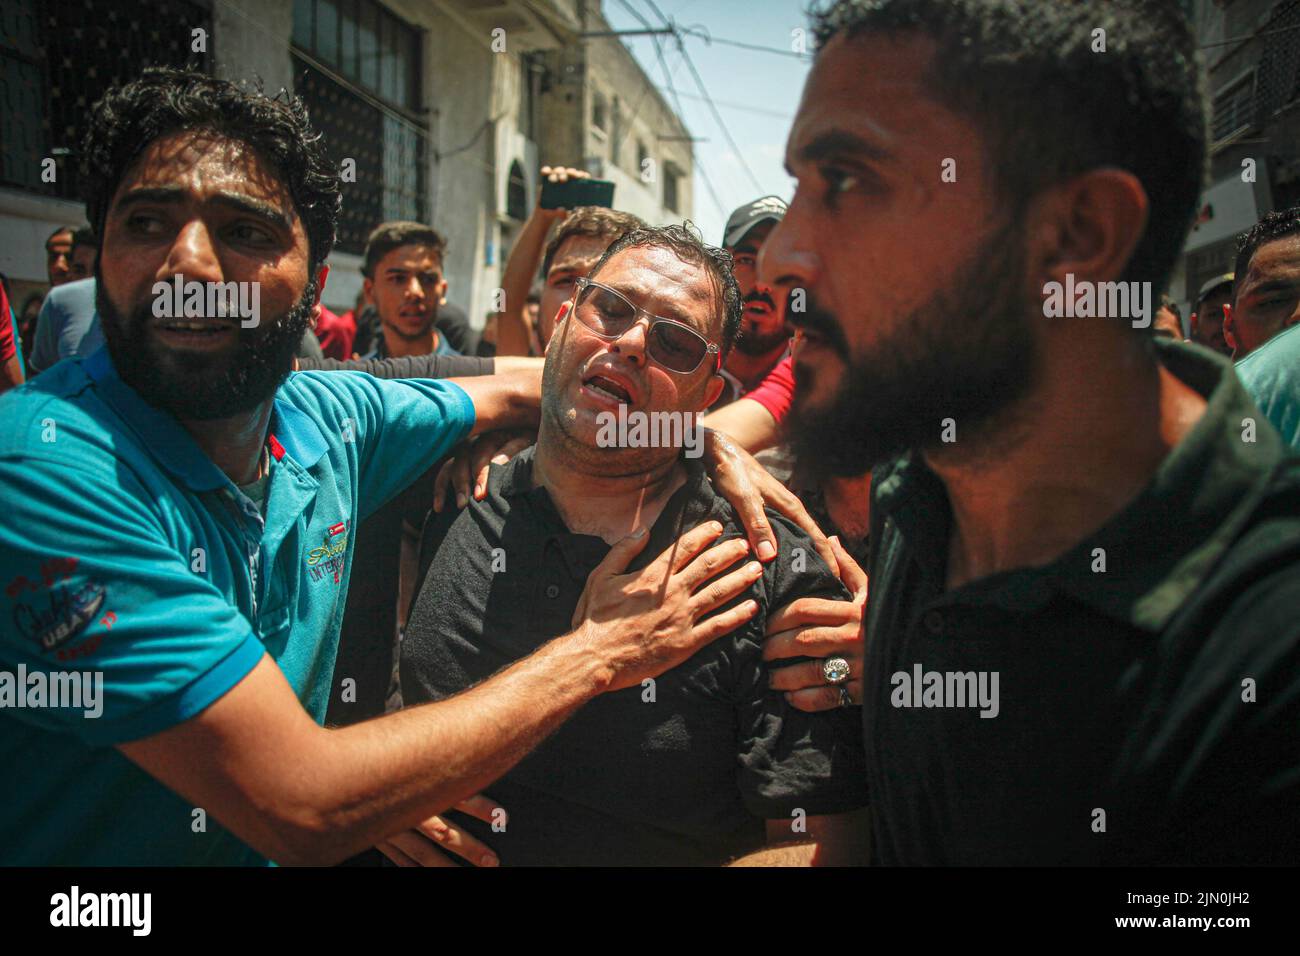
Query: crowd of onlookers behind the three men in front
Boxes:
[{"xmin": 0, "ymin": 180, "xmax": 1300, "ymax": 455}]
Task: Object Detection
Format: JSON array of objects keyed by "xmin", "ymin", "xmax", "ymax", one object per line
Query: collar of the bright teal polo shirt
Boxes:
[{"xmin": 82, "ymin": 346, "xmax": 329, "ymax": 492}]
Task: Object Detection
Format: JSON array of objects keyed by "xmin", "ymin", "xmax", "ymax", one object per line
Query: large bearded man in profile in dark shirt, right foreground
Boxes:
[{"xmin": 738, "ymin": 0, "xmax": 1300, "ymax": 865}]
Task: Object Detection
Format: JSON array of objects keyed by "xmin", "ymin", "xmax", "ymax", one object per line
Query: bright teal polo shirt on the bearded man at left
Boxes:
[{"xmin": 0, "ymin": 350, "xmax": 475, "ymax": 865}]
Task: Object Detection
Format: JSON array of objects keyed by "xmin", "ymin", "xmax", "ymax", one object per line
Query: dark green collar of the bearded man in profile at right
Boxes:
[{"xmin": 874, "ymin": 339, "xmax": 1284, "ymax": 632}]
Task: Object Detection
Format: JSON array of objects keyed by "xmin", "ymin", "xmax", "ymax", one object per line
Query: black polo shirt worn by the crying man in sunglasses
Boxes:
[{"xmin": 402, "ymin": 449, "xmax": 866, "ymax": 865}]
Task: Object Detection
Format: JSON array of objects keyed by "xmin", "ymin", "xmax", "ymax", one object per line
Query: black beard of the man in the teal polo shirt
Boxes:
[{"xmin": 95, "ymin": 269, "xmax": 316, "ymax": 421}]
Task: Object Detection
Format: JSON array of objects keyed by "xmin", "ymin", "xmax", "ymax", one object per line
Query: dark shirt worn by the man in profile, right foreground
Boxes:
[{"xmin": 863, "ymin": 339, "xmax": 1300, "ymax": 864}]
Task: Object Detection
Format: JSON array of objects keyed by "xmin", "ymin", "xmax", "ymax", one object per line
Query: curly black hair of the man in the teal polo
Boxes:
[{"xmin": 81, "ymin": 68, "xmax": 343, "ymax": 274}]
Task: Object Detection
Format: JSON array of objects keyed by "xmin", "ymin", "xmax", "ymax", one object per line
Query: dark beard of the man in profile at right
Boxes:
[{"xmin": 787, "ymin": 224, "xmax": 1036, "ymax": 477}]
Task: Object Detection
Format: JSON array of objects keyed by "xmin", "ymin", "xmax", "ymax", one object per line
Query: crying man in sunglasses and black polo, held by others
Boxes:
[{"xmin": 402, "ymin": 226, "xmax": 863, "ymax": 865}]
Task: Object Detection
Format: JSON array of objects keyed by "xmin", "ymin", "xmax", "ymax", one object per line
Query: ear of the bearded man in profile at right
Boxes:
[{"xmin": 1031, "ymin": 166, "xmax": 1151, "ymax": 295}]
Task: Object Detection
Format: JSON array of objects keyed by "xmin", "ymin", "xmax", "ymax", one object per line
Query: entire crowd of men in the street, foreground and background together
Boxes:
[{"xmin": 0, "ymin": 0, "xmax": 1300, "ymax": 865}]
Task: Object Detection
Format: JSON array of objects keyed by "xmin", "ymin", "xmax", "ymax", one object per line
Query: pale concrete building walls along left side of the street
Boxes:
[{"xmin": 0, "ymin": 0, "xmax": 691, "ymax": 335}]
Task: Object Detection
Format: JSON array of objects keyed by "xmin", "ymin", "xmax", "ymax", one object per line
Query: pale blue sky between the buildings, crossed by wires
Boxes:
[{"xmin": 603, "ymin": 0, "xmax": 811, "ymax": 243}]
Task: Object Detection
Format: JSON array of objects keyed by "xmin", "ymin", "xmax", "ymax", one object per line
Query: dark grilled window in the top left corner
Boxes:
[{"xmin": 0, "ymin": 0, "xmax": 212, "ymax": 199}]
